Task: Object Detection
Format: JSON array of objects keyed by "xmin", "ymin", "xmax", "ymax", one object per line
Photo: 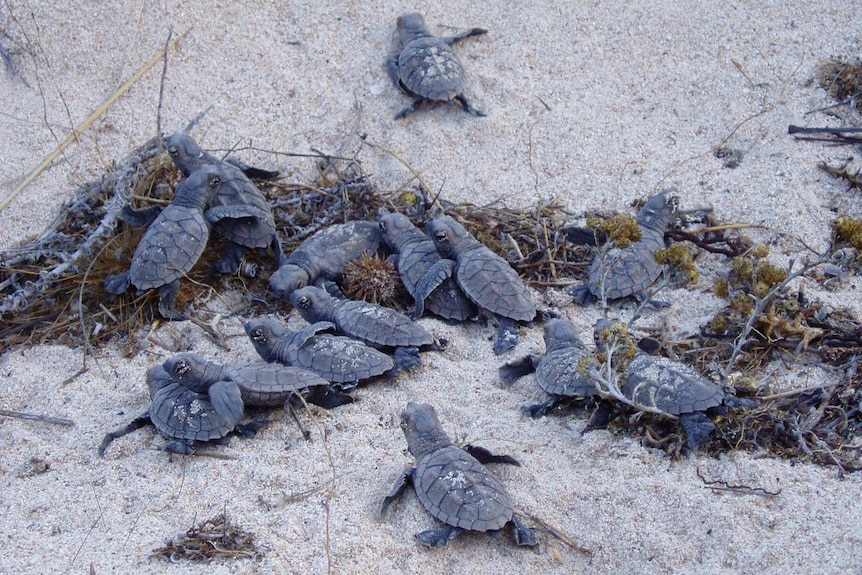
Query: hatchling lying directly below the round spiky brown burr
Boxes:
[{"xmin": 290, "ymin": 286, "xmax": 434, "ymax": 370}]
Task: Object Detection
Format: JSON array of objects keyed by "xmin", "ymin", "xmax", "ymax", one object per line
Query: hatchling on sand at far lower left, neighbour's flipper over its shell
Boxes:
[{"xmin": 99, "ymin": 365, "xmax": 251, "ymax": 456}]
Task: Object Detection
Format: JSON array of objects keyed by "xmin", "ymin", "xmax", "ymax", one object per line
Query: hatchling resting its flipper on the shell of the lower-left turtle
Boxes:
[{"xmin": 163, "ymin": 353, "xmax": 353, "ymax": 409}]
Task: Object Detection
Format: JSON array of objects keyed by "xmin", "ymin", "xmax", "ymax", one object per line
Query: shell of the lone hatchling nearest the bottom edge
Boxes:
[{"xmin": 413, "ymin": 446, "xmax": 514, "ymax": 531}]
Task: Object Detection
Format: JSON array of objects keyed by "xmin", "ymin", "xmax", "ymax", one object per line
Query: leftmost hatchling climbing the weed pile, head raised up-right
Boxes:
[{"xmin": 104, "ymin": 166, "xmax": 226, "ymax": 319}]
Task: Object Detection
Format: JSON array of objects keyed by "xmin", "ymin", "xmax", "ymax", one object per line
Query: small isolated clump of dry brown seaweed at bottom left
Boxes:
[{"xmin": 153, "ymin": 513, "xmax": 263, "ymax": 563}]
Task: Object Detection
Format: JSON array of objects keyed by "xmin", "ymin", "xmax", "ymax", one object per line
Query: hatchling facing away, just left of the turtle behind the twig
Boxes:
[{"xmin": 499, "ymin": 318, "xmax": 596, "ymax": 417}]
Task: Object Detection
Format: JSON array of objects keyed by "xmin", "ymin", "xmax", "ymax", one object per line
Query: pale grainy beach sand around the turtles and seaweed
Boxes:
[{"xmin": 0, "ymin": 0, "xmax": 862, "ymax": 574}]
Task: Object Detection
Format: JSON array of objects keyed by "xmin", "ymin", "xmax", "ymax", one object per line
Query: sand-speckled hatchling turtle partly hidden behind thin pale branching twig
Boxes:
[{"xmin": 591, "ymin": 319, "xmax": 753, "ymax": 451}]
